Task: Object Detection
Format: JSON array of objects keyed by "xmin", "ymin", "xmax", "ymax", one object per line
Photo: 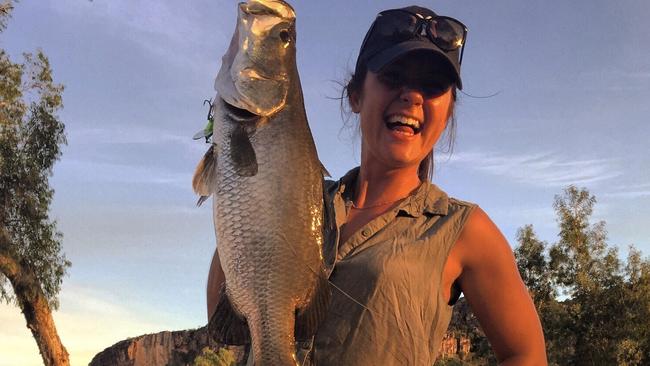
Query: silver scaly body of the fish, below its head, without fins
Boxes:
[{"xmin": 214, "ymin": 98, "xmax": 323, "ymax": 365}]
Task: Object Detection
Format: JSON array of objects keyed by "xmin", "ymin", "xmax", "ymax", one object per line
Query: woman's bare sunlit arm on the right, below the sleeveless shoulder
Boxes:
[{"xmin": 454, "ymin": 207, "xmax": 547, "ymax": 365}]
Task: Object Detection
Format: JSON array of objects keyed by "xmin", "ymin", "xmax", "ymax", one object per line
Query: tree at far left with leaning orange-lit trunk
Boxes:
[{"xmin": 0, "ymin": 2, "xmax": 70, "ymax": 365}]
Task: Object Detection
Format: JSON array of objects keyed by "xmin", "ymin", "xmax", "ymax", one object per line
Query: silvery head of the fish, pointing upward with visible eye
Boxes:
[{"xmin": 215, "ymin": 0, "xmax": 296, "ymax": 117}]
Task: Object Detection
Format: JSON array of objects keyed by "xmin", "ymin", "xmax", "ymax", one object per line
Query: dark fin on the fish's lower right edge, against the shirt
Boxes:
[{"xmin": 295, "ymin": 270, "xmax": 332, "ymax": 342}]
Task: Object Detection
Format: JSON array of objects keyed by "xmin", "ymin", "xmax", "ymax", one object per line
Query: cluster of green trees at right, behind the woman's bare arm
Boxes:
[{"xmin": 515, "ymin": 186, "xmax": 650, "ymax": 365}]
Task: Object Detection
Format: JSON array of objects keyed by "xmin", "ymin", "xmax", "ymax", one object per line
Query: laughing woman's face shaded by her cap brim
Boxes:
[{"xmin": 350, "ymin": 54, "xmax": 453, "ymax": 171}]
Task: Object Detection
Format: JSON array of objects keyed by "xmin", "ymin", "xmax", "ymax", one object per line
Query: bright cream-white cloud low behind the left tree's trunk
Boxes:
[{"xmin": 0, "ymin": 284, "xmax": 198, "ymax": 366}]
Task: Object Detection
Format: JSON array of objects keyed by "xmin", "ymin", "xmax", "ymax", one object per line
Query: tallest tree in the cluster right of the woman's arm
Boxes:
[{"xmin": 550, "ymin": 186, "xmax": 623, "ymax": 365}]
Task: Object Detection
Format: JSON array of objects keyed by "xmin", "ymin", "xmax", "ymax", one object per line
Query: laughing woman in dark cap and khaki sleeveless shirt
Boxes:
[{"xmin": 208, "ymin": 6, "xmax": 546, "ymax": 365}]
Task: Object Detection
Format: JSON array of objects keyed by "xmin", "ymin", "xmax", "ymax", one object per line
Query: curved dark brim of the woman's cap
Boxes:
[{"xmin": 366, "ymin": 41, "xmax": 463, "ymax": 89}]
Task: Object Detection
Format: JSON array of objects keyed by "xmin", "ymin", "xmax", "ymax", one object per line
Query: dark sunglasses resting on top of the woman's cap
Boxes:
[{"xmin": 361, "ymin": 9, "xmax": 467, "ymax": 65}]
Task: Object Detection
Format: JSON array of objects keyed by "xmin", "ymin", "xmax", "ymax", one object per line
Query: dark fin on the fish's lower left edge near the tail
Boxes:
[{"xmin": 208, "ymin": 283, "xmax": 251, "ymax": 346}]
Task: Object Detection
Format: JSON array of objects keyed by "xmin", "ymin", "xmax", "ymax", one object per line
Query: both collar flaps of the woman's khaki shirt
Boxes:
[{"xmin": 337, "ymin": 167, "xmax": 449, "ymax": 217}]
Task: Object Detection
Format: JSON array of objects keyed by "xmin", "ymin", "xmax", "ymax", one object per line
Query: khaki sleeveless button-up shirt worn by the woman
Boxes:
[{"xmin": 309, "ymin": 168, "xmax": 476, "ymax": 366}]
